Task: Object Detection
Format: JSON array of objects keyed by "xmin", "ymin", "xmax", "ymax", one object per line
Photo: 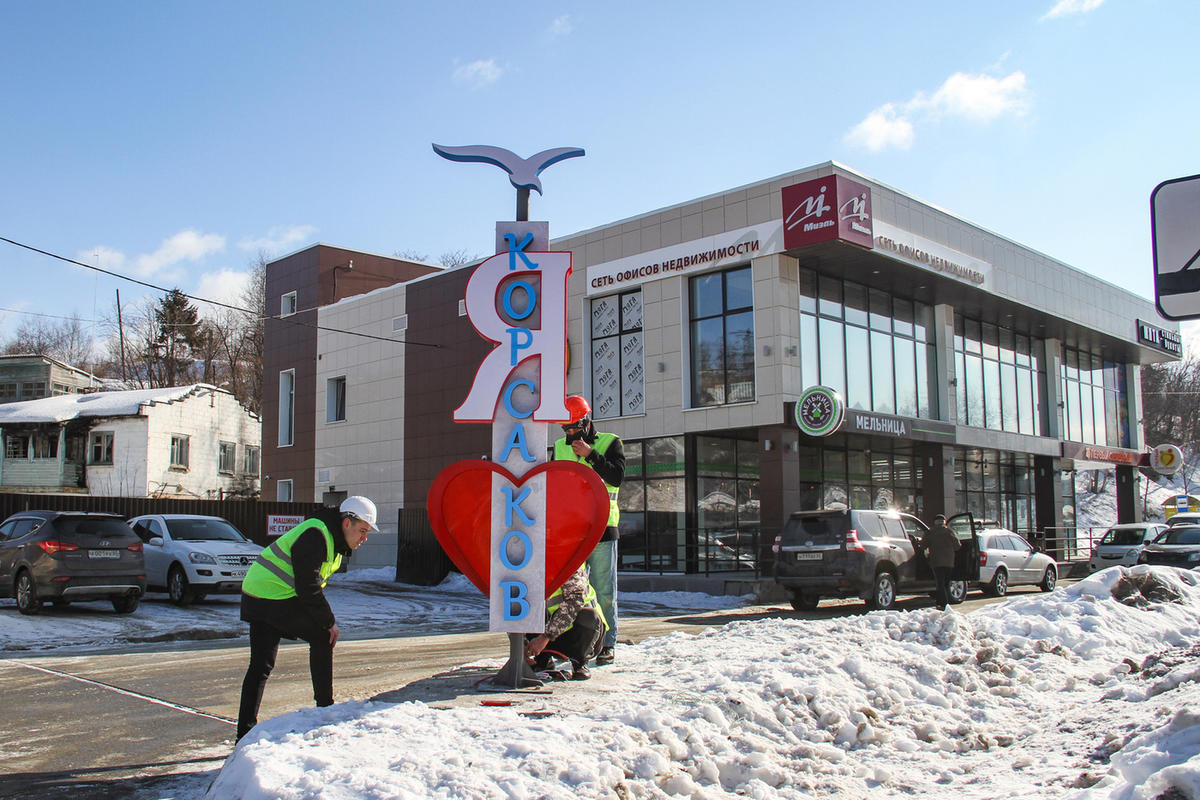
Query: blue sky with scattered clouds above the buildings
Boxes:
[{"xmin": 0, "ymin": 0, "xmax": 1200, "ymax": 347}]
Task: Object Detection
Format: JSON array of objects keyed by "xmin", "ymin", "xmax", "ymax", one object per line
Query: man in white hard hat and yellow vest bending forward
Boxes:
[{"xmin": 238, "ymin": 497, "xmax": 379, "ymax": 739}]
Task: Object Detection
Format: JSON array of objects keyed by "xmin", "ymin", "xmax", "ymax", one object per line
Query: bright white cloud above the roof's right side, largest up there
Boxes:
[{"xmin": 844, "ymin": 71, "xmax": 1030, "ymax": 152}]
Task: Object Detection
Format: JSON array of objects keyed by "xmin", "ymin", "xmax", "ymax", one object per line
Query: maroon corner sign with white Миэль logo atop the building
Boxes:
[{"xmin": 782, "ymin": 175, "xmax": 875, "ymax": 249}]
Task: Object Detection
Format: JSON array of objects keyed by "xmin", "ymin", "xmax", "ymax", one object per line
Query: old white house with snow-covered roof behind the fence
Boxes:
[{"xmin": 0, "ymin": 384, "xmax": 262, "ymax": 498}]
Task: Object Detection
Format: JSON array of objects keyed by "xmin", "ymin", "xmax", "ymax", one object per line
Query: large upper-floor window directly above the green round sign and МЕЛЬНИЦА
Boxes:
[{"xmin": 799, "ymin": 269, "xmax": 938, "ymax": 419}]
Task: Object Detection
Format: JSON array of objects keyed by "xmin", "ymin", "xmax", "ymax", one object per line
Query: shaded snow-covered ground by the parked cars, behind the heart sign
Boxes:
[{"xmin": 0, "ymin": 567, "xmax": 752, "ymax": 657}]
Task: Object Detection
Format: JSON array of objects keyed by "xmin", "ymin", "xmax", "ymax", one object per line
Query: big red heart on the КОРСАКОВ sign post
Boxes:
[{"xmin": 427, "ymin": 461, "xmax": 608, "ymax": 597}]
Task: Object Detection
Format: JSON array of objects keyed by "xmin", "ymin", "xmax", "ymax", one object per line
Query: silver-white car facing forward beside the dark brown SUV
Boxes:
[{"xmin": 130, "ymin": 513, "xmax": 263, "ymax": 606}]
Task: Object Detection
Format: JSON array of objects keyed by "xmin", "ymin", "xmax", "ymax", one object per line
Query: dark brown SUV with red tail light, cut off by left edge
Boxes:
[{"xmin": 0, "ymin": 511, "xmax": 146, "ymax": 614}]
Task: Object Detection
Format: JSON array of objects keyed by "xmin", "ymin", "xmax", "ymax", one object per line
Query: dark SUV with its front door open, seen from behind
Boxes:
[{"xmin": 773, "ymin": 509, "xmax": 979, "ymax": 610}]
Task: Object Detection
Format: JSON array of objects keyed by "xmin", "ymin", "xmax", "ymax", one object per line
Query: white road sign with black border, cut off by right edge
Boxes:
[{"xmin": 1150, "ymin": 175, "xmax": 1200, "ymax": 319}]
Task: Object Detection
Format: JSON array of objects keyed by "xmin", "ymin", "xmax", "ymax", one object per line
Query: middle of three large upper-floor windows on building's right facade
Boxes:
[{"xmin": 954, "ymin": 315, "xmax": 1045, "ymax": 435}]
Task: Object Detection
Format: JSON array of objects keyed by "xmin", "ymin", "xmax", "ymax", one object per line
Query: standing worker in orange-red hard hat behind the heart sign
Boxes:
[{"xmin": 554, "ymin": 395, "xmax": 625, "ymax": 666}]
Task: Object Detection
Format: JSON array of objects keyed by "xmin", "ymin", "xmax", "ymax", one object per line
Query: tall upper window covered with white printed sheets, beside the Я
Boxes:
[{"xmin": 592, "ymin": 290, "xmax": 646, "ymax": 419}]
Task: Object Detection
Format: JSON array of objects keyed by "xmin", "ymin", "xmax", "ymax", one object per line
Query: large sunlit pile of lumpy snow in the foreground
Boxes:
[{"xmin": 209, "ymin": 567, "xmax": 1200, "ymax": 800}]
